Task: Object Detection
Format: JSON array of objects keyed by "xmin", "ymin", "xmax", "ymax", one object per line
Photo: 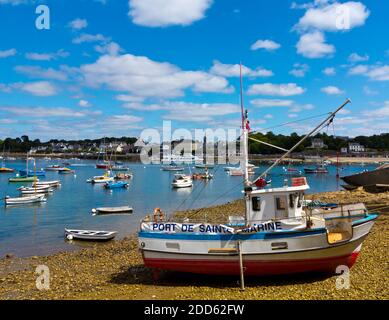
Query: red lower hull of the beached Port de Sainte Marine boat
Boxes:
[{"xmin": 144, "ymin": 252, "xmax": 359, "ymax": 275}]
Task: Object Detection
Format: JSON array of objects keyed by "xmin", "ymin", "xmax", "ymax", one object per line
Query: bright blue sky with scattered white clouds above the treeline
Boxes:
[{"xmin": 0, "ymin": 0, "xmax": 389, "ymax": 140}]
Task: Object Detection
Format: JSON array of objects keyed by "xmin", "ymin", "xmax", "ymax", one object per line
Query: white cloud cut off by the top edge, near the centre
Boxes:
[{"xmin": 128, "ymin": 0, "xmax": 213, "ymax": 27}]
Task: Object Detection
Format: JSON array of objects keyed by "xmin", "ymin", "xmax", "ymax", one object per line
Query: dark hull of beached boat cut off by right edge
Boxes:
[{"xmin": 341, "ymin": 164, "xmax": 389, "ymax": 187}]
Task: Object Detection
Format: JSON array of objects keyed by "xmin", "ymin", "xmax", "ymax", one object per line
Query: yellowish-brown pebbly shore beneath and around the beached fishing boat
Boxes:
[{"xmin": 0, "ymin": 191, "xmax": 389, "ymax": 300}]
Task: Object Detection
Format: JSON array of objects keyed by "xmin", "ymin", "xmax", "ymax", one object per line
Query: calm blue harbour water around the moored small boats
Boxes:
[{"xmin": 0, "ymin": 160, "xmax": 375, "ymax": 257}]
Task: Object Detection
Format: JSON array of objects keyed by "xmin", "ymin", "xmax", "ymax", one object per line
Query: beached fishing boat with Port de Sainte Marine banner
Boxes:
[{"xmin": 138, "ymin": 68, "xmax": 377, "ymax": 280}]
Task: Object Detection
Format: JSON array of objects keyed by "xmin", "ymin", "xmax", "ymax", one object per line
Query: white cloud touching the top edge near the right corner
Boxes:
[{"xmin": 295, "ymin": 1, "xmax": 370, "ymax": 32}]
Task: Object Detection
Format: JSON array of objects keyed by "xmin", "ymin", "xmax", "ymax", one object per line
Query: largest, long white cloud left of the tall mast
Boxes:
[{"xmin": 81, "ymin": 54, "xmax": 233, "ymax": 97}]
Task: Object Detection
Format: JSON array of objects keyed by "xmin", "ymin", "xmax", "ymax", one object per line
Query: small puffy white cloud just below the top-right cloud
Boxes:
[{"xmin": 296, "ymin": 31, "xmax": 336, "ymax": 59}]
